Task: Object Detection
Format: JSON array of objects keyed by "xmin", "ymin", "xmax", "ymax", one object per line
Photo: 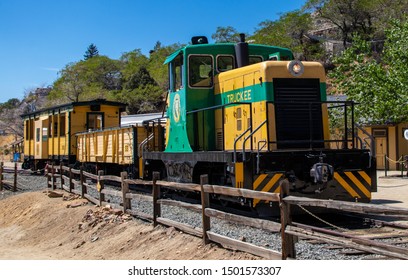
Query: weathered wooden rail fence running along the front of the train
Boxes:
[{"xmin": 43, "ymin": 165, "xmax": 408, "ymax": 259}]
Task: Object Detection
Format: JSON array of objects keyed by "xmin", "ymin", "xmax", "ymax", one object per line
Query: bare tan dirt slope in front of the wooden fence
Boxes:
[{"xmin": 0, "ymin": 192, "xmax": 259, "ymax": 260}]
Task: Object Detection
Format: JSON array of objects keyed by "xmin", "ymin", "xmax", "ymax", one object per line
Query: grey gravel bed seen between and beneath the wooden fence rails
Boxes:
[{"xmin": 0, "ymin": 174, "xmax": 396, "ymax": 260}]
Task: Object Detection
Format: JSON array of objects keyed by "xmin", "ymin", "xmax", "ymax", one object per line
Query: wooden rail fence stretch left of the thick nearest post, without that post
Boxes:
[{"xmin": 47, "ymin": 166, "xmax": 282, "ymax": 259}]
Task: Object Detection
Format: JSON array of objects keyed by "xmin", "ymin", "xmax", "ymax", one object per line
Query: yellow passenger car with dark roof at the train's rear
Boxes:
[{"xmin": 22, "ymin": 99, "xmax": 126, "ymax": 170}]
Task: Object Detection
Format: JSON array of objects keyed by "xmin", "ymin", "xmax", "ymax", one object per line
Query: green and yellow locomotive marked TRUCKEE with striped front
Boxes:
[{"xmin": 141, "ymin": 34, "xmax": 376, "ymax": 206}]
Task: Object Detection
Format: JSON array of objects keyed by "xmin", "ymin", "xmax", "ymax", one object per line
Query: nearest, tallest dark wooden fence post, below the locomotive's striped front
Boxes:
[{"xmin": 280, "ymin": 179, "xmax": 296, "ymax": 260}]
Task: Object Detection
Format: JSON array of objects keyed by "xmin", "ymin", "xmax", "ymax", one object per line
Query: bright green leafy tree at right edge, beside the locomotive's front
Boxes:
[{"xmin": 330, "ymin": 20, "xmax": 408, "ymax": 124}]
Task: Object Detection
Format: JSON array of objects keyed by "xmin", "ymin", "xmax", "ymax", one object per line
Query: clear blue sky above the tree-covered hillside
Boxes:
[{"xmin": 0, "ymin": 0, "xmax": 306, "ymax": 103}]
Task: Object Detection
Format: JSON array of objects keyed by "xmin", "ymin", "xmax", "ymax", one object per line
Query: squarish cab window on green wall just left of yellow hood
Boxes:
[{"xmin": 188, "ymin": 55, "xmax": 213, "ymax": 88}]
